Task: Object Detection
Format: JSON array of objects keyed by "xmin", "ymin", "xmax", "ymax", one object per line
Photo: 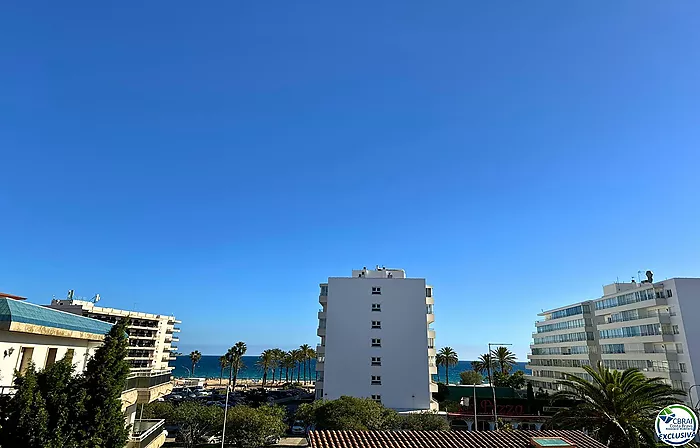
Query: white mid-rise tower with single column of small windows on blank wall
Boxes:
[{"xmin": 316, "ymin": 266, "xmax": 437, "ymax": 410}]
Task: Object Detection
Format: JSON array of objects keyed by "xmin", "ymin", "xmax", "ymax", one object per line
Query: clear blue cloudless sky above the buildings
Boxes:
[{"xmin": 0, "ymin": 0, "xmax": 700, "ymax": 360}]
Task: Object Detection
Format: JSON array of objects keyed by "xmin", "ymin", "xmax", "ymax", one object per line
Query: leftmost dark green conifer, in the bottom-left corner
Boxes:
[{"xmin": 0, "ymin": 363, "xmax": 49, "ymax": 448}]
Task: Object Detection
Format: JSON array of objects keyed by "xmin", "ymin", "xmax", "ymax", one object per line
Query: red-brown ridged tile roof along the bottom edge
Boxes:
[{"xmin": 308, "ymin": 430, "xmax": 606, "ymax": 448}]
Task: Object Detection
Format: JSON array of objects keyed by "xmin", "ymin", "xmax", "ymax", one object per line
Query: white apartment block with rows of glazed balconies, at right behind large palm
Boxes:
[{"xmin": 528, "ymin": 272, "xmax": 700, "ymax": 403}]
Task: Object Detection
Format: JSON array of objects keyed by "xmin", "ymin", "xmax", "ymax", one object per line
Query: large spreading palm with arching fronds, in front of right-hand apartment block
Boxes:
[{"xmin": 551, "ymin": 362, "xmax": 685, "ymax": 448}]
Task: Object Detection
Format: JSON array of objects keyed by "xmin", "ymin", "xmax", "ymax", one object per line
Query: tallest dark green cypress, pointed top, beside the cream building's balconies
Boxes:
[{"xmin": 81, "ymin": 319, "xmax": 131, "ymax": 448}]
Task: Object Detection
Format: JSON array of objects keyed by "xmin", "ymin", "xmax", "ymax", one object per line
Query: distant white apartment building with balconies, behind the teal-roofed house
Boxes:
[{"xmin": 48, "ymin": 291, "xmax": 181, "ymax": 372}]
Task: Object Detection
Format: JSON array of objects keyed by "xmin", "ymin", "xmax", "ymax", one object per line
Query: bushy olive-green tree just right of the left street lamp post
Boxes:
[{"xmin": 226, "ymin": 406, "xmax": 287, "ymax": 448}]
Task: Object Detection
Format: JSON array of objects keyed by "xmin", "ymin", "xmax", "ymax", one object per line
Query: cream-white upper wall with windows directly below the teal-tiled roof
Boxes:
[{"xmin": 0, "ymin": 330, "xmax": 102, "ymax": 386}]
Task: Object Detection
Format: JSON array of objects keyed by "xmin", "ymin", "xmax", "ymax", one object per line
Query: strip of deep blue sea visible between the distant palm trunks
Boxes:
[{"xmin": 171, "ymin": 355, "xmax": 530, "ymax": 384}]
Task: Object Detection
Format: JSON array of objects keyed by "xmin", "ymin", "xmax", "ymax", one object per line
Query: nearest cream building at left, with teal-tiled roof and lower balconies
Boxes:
[{"xmin": 0, "ymin": 294, "xmax": 172, "ymax": 448}]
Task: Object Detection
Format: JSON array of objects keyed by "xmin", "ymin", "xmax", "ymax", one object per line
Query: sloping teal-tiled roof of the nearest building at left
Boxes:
[{"xmin": 0, "ymin": 297, "xmax": 112, "ymax": 336}]
